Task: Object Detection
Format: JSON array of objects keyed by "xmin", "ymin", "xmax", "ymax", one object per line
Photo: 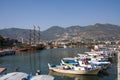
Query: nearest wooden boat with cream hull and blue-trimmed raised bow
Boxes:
[{"xmin": 48, "ymin": 63, "xmax": 100, "ymax": 75}]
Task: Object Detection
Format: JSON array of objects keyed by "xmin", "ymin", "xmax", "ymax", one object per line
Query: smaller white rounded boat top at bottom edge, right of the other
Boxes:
[{"xmin": 30, "ymin": 75, "xmax": 54, "ymax": 80}]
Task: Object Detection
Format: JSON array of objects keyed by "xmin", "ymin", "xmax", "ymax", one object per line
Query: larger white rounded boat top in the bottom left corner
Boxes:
[{"xmin": 0, "ymin": 72, "xmax": 28, "ymax": 80}]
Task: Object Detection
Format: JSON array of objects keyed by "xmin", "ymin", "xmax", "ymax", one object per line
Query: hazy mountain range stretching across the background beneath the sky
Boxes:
[{"xmin": 0, "ymin": 23, "xmax": 120, "ymax": 41}]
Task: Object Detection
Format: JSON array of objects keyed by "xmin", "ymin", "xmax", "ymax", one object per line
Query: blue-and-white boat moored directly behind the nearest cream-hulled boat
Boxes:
[{"xmin": 61, "ymin": 55, "xmax": 111, "ymax": 70}]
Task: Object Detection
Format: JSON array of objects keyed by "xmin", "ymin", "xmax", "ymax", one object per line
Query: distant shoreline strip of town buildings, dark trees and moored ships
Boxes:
[{"xmin": 0, "ymin": 32, "xmax": 120, "ymax": 51}]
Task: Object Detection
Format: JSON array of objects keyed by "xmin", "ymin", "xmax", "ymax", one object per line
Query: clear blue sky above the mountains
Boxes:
[{"xmin": 0, "ymin": 0, "xmax": 120, "ymax": 31}]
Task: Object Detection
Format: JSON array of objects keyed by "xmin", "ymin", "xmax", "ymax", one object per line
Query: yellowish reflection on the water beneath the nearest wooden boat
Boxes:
[{"xmin": 49, "ymin": 71, "xmax": 99, "ymax": 80}]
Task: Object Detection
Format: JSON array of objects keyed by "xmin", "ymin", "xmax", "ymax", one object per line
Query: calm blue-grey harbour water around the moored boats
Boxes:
[{"xmin": 0, "ymin": 48, "xmax": 117, "ymax": 80}]
